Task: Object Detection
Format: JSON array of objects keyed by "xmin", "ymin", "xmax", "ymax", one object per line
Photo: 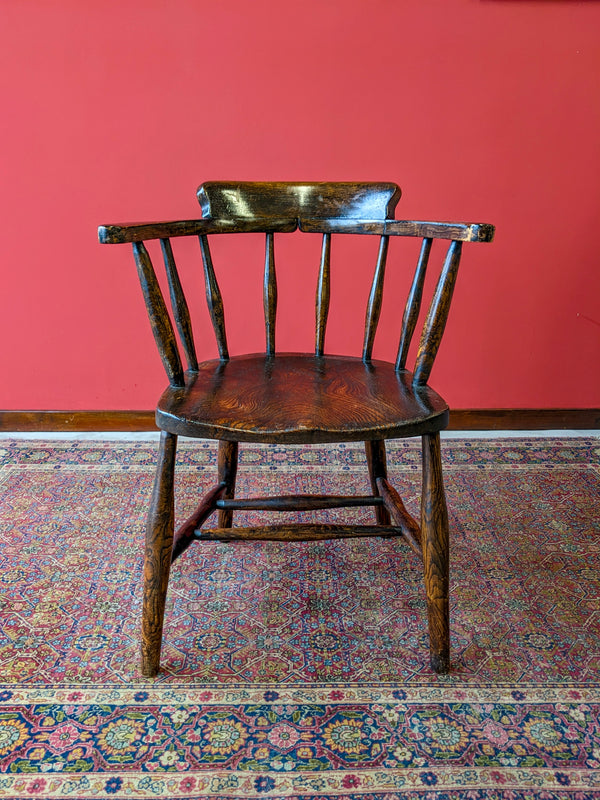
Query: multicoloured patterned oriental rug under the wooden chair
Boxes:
[{"xmin": 0, "ymin": 439, "xmax": 600, "ymax": 800}]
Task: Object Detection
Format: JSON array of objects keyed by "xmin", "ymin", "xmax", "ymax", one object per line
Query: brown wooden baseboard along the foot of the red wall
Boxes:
[{"xmin": 0, "ymin": 408, "xmax": 600, "ymax": 433}]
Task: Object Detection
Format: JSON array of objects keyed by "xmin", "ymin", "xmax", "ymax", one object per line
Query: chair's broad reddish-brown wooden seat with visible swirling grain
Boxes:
[{"xmin": 157, "ymin": 353, "xmax": 448, "ymax": 444}]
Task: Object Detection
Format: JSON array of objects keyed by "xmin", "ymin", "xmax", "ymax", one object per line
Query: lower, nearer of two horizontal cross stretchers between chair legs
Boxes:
[{"xmin": 197, "ymin": 523, "xmax": 402, "ymax": 542}]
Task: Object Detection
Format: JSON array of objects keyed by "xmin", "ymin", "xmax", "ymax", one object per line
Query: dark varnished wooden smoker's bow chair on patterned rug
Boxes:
[{"xmin": 99, "ymin": 182, "xmax": 494, "ymax": 676}]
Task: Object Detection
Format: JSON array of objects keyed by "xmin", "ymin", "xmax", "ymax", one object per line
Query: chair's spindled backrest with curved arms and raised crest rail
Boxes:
[{"xmin": 99, "ymin": 181, "xmax": 494, "ymax": 394}]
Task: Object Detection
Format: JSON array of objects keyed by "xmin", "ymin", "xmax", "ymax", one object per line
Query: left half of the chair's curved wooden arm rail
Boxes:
[{"xmin": 98, "ymin": 219, "xmax": 298, "ymax": 244}]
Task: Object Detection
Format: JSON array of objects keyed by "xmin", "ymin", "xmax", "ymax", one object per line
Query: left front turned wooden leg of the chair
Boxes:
[{"xmin": 141, "ymin": 431, "xmax": 177, "ymax": 677}]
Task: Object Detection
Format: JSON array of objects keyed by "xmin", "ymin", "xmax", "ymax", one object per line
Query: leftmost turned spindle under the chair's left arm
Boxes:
[{"xmin": 133, "ymin": 242, "xmax": 185, "ymax": 386}]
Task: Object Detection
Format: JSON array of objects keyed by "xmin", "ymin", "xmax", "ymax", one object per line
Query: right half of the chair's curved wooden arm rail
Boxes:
[{"xmin": 299, "ymin": 218, "xmax": 495, "ymax": 242}]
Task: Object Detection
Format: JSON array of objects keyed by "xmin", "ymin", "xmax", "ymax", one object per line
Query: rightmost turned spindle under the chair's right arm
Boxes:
[{"xmin": 413, "ymin": 241, "xmax": 462, "ymax": 385}]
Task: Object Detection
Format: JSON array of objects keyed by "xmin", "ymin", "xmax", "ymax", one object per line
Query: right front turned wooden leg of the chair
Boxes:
[{"xmin": 421, "ymin": 433, "xmax": 450, "ymax": 673}]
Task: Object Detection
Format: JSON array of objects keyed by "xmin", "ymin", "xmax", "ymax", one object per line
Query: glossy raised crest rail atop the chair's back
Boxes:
[{"xmin": 197, "ymin": 181, "xmax": 400, "ymax": 220}]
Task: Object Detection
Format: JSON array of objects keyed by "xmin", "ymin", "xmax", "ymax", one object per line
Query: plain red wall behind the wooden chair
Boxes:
[{"xmin": 0, "ymin": 0, "xmax": 600, "ymax": 409}]
